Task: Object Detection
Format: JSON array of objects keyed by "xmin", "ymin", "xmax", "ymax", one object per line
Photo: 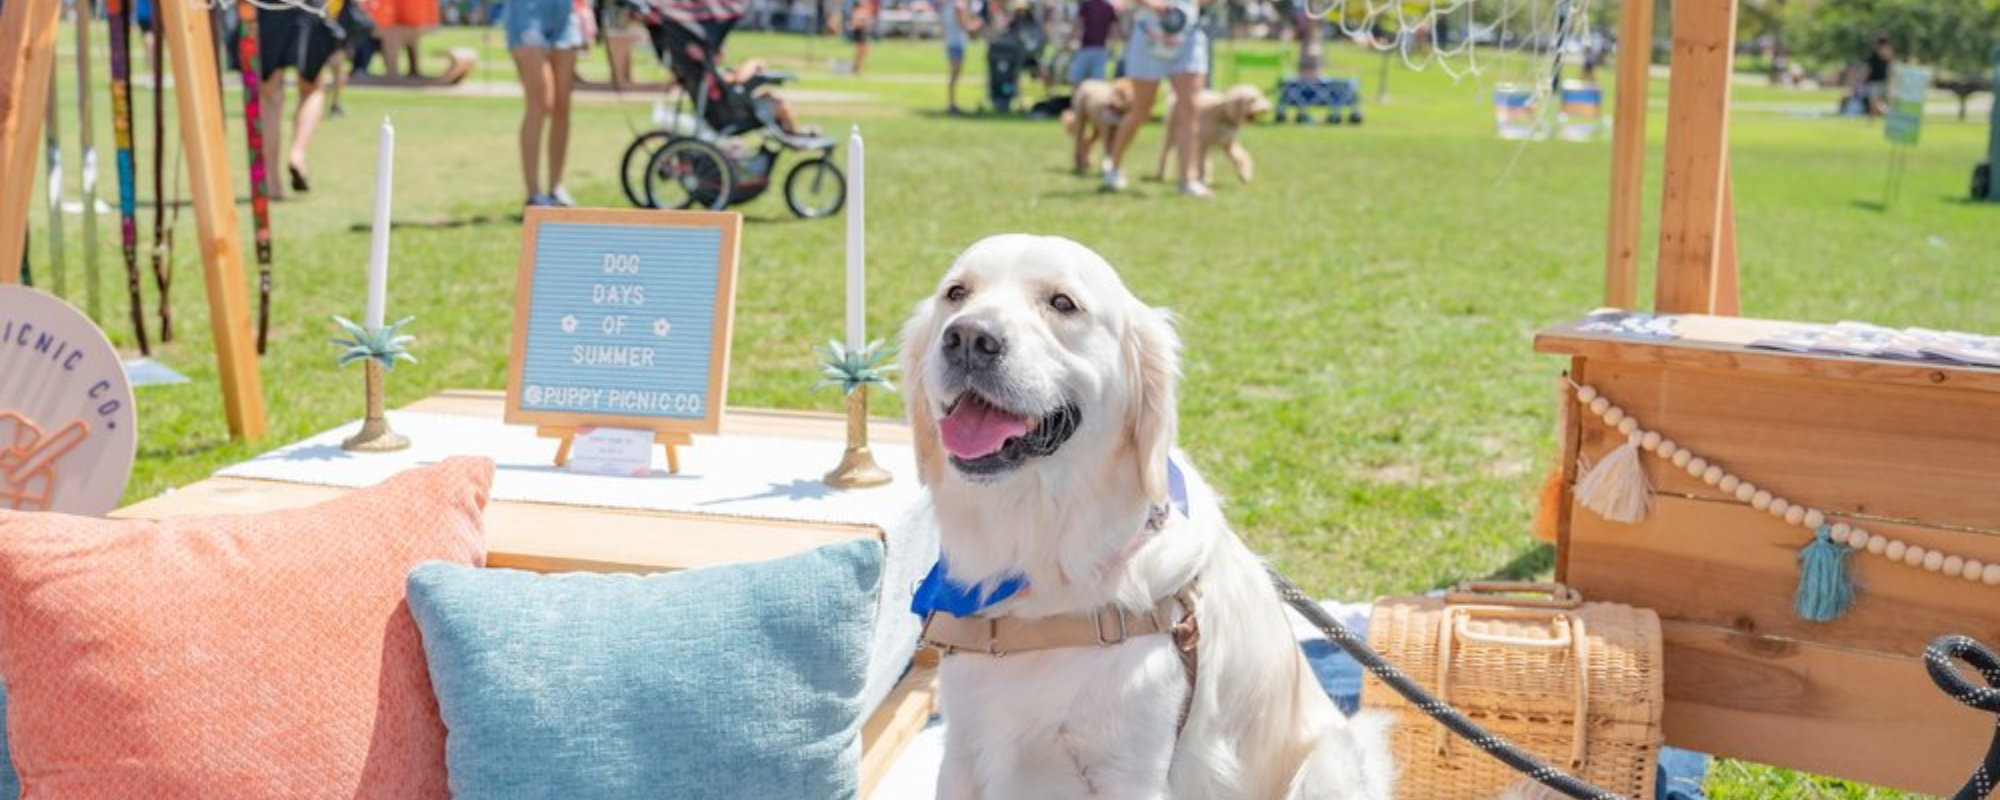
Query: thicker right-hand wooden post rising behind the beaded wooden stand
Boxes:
[{"xmin": 1654, "ymin": 0, "xmax": 1736, "ymax": 314}]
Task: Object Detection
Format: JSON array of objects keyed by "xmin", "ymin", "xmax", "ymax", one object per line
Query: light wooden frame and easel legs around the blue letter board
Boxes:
[{"xmin": 504, "ymin": 208, "xmax": 742, "ymax": 472}]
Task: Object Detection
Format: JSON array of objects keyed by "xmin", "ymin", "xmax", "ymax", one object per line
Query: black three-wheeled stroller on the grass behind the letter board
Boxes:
[{"xmin": 620, "ymin": 0, "xmax": 848, "ymax": 218}]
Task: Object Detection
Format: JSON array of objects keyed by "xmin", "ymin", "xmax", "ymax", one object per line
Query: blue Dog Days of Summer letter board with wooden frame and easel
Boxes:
[{"xmin": 506, "ymin": 208, "xmax": 742, "ymax": 476}]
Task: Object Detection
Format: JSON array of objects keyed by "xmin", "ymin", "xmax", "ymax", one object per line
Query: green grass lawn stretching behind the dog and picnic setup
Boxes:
[{"xmin": 19, "ymin": 30, "xmax": 2000, "ymax": 798}]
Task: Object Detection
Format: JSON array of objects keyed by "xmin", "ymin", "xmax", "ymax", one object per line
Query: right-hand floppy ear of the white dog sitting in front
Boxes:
[{"xmin": 1124, "ymin": 300, "xmax": 1180, "ymax": 502}]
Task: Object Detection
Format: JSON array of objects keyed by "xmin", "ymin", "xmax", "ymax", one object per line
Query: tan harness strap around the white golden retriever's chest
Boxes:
[{"xmin": 922, "ymin": 578, "xmax": 1202, "ymax": 736}]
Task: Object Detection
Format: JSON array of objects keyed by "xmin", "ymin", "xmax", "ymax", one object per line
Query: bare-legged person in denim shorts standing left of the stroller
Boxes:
[{"xmin": 504, "ymin": 0, "xmax": 590, "ymax": 206}]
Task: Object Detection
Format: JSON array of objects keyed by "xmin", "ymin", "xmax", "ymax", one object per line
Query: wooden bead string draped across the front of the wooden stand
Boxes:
[{"xmin": 1570, "ymin": 382, "xmax": 2000, "ymax": 604}]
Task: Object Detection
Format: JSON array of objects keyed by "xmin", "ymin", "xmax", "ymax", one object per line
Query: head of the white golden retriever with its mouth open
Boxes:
[{"xmin": 902, "ymin": 234, "xmax": 1178, "ymax": 500}]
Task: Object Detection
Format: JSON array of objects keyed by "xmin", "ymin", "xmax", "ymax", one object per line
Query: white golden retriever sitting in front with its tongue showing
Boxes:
[{"xmin": 902, "ymin": 234, "xmax": 1392, "ymax": 800}]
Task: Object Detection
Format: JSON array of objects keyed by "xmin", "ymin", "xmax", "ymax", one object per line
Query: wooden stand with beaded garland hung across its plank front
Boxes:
[{"xmin": 1536, "ymin": 316, "xmax": 2000, "ymax": 794}]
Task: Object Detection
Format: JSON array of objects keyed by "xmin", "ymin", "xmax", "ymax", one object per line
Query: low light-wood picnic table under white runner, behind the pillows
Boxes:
[{"xmin": 112, "ymin": 390, "xmax": 936, "ymax": 796}]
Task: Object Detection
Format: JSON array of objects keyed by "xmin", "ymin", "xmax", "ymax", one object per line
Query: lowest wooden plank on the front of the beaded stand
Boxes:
[{"xmin": 1662, "ymin": 622, "xmax": 1994, "ymax": 794}]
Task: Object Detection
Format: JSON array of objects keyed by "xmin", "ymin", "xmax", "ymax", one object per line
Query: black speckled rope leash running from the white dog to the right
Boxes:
[{"xmin": 1266, "ymin": 566, "xmax": 2000, "ymax": 800}]
